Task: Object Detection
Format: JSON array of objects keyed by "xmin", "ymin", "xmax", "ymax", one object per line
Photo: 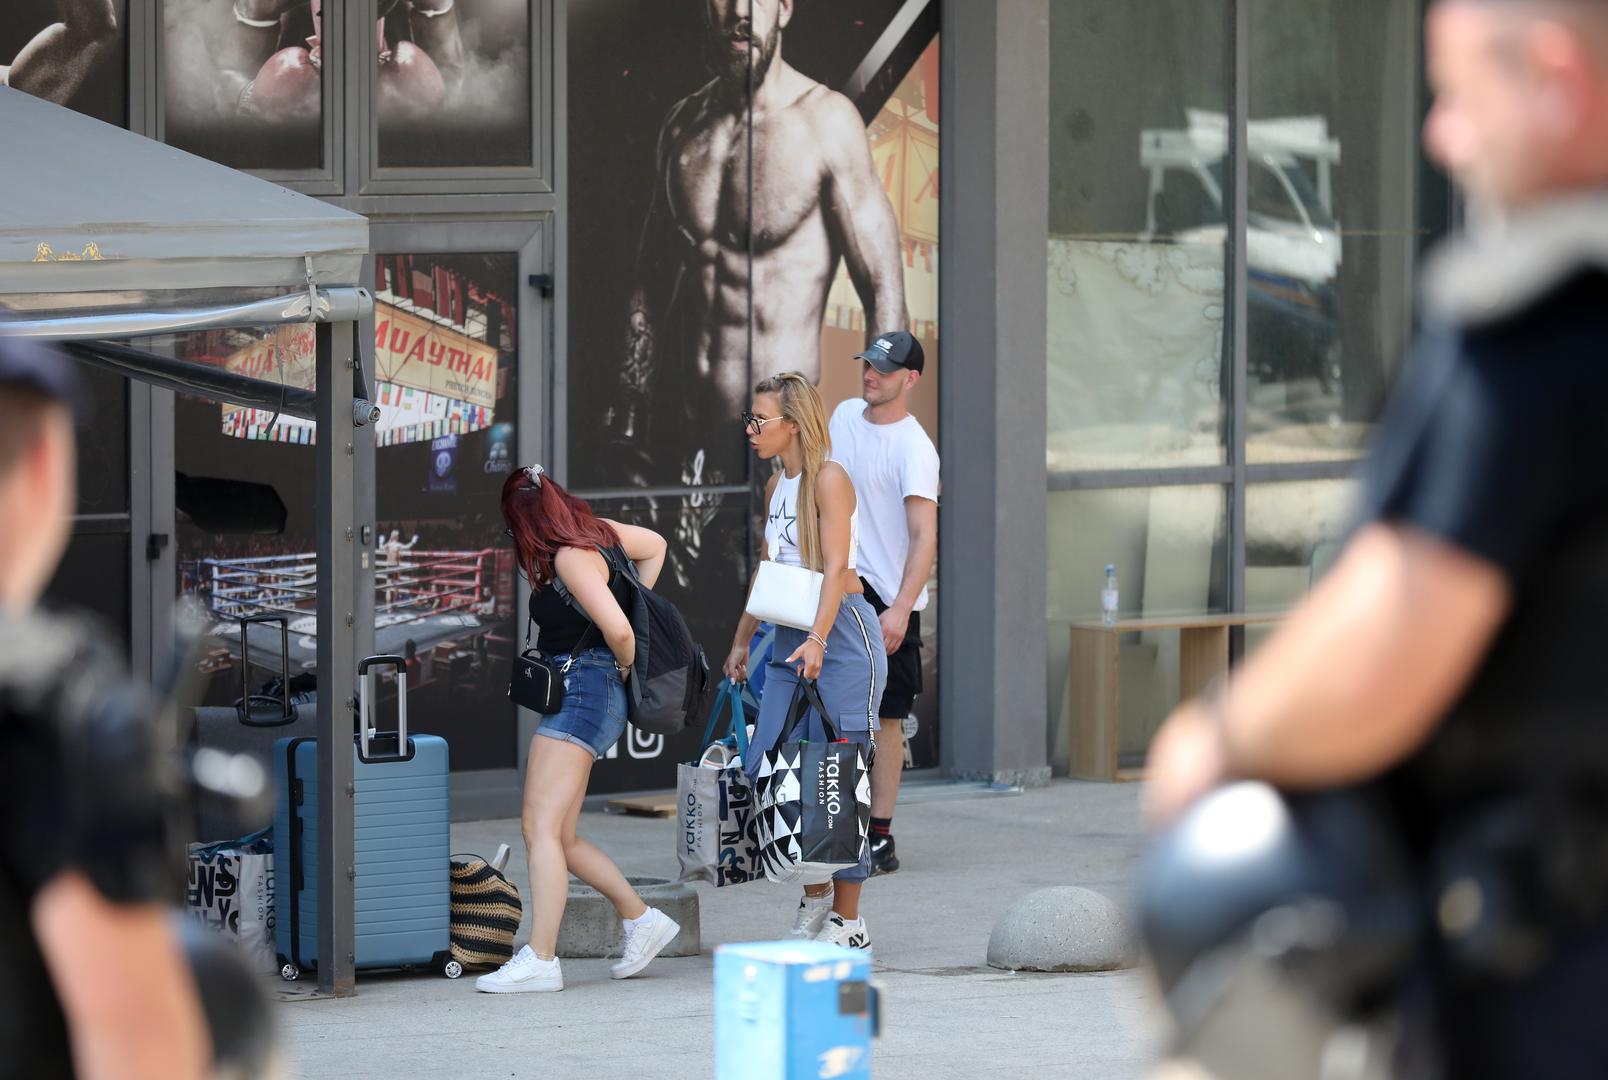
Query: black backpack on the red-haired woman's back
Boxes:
[{"xmin": 553, "ymin": 548, "xmax": 709, "ymax": 734}]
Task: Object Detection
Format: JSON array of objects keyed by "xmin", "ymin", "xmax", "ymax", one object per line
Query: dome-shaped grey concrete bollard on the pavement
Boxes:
[{"xmin": 989, "ymin": 886, "xmax": 1138, "ymax": 971}]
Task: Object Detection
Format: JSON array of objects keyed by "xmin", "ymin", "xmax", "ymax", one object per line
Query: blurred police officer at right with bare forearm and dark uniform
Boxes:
[{"xmin": 1147, "ymin": 0, "xmax": 1608, "ymax": 1080}]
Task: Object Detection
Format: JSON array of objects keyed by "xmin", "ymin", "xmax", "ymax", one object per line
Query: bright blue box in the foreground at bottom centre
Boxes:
[{"xmin": 714, "ymin": 942, "xmax": 876, "ymax": 1080}]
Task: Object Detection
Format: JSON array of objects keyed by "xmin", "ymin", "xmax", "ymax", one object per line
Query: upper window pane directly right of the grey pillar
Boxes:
[{"xmin": 1047, "ymin": 0, "xmax": 1232, "ymax": 474}]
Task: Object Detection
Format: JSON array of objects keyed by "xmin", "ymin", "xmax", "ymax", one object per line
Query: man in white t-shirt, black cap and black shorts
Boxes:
[{"xmin": 831, "ymin": 329, "xmax": 937, "ymax": 874}]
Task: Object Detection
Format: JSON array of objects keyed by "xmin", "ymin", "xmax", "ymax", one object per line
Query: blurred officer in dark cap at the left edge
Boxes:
[{"xmin": 0, "ymin": 338, "xmax": 209, "ymax": 1080}]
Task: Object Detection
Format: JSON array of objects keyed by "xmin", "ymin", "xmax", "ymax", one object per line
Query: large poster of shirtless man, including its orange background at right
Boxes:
[{"xmin": 566, "ymin": 0, "xmax": 941, "ymax": 777}]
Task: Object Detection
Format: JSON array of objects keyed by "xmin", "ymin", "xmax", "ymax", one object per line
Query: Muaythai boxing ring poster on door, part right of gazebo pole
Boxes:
[{"xmin": 375, "ymin": 254, "xmax": 523, "ymax": 771}]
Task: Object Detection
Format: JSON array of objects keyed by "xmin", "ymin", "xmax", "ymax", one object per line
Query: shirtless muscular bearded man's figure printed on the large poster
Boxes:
[{"xmin": 619, "ymin": 0, "xmax": 909, "ymax": 439}]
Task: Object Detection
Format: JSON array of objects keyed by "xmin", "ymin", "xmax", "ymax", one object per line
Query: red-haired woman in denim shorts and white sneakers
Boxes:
[{"xmin": 474, "ymin": 464, "xmax": 680, "ymax": 993}]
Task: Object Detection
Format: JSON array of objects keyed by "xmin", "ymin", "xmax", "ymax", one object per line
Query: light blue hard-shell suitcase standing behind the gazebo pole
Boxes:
[{"xmin": 273, "ymin": 656, "xmax": 463, "ymax": 980}]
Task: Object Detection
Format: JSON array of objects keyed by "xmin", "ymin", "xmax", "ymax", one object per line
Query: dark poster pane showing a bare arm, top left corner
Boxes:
[{"xmin": 0, "ymin": 0, "xmax": 129, "ymax": 127}]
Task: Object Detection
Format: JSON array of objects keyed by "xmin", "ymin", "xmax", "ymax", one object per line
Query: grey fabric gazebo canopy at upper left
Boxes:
[{"xmin": 0, "ymin": 87, "xmax": 373, "ymax": 339}]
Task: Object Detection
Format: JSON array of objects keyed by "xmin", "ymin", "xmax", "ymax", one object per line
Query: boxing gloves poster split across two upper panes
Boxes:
[{"xmin": 162, "ymin": 0, "xmax": 531, "ymax": 170}]
